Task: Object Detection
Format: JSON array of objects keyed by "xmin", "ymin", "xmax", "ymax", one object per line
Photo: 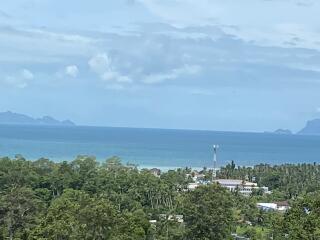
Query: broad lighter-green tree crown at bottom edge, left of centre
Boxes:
[{"xmin": 30, "ymin": 190, "xmax": 118, "ymax": 239}]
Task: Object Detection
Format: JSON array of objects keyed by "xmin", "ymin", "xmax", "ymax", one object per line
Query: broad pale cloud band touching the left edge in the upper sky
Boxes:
[{"xmin": 0, "ymin": 24, "xmax": 99, "ymax": 64}]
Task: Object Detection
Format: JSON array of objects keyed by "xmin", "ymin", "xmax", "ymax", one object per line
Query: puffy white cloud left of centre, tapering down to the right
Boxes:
[{"xmin": 88, "ymin": 53, "xmax": 133, "ymax": 86}]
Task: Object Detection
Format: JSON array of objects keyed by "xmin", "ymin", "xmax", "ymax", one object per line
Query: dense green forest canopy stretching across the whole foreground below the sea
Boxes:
[{"xmin": 0, "ymin": 156, "xmax": 320, "ymax": 240}]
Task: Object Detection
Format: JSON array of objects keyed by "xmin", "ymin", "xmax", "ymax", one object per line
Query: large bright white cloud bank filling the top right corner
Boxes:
[{"xmin": 139, "ymin": 0, "xmax": 320, "ymax": 50}]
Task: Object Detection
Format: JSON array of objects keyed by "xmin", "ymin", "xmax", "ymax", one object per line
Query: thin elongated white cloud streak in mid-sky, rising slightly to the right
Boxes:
[{"xmin": 142, "ymin": 65, "xmax": 201, "ymax": 84}]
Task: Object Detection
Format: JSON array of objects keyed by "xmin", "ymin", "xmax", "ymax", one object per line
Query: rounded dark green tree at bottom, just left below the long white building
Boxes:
[{"xmin": 182, "ymin": 184, "xmax": 234, "ymax": 240}]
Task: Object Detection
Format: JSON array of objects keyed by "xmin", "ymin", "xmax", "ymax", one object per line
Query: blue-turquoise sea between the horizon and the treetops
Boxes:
[{"xmin": 0, "ymin": 125, "xmax": 320, "ymax": 167}]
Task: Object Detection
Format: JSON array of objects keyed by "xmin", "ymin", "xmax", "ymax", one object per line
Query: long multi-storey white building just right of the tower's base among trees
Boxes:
[{"xmin": 214, "ymin": 179, "xmax": 270, "ymax": 196}]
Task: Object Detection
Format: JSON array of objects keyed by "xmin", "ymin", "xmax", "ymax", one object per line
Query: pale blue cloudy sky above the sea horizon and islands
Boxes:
[{"xmin": 0, "ymin": 0, "xmax": 320, "ymax": 132}]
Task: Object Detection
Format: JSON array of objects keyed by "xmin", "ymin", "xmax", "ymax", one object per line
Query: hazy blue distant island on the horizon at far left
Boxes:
[{"xmin": 0, "ymin": 111, "xmax": 75, "ymax": 126}]
